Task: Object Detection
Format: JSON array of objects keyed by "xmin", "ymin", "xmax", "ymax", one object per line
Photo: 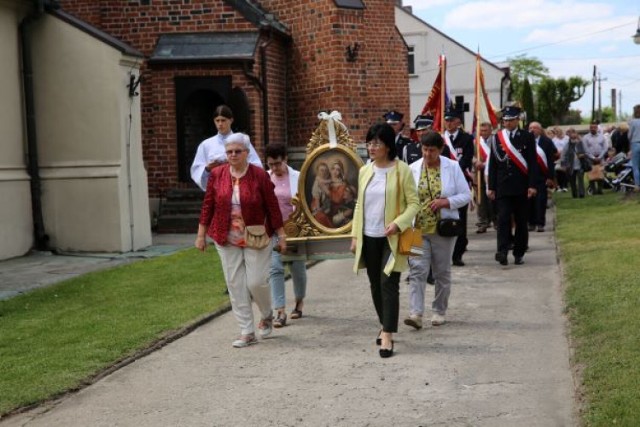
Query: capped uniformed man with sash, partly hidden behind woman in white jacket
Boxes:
[{"xmin": 444, "ymin": 110, "xmax": 474, "ymax": 267}]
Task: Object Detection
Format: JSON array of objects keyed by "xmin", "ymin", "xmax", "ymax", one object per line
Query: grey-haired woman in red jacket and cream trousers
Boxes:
[{"xmin": 195, "ymin": 133, "xmax": 286, "ymax": 348}]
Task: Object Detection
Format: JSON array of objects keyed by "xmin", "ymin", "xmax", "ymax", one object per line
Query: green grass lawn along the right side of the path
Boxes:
[{"xmin": 554, "ymin": 193, "xmax": 640, "ymax": 427}]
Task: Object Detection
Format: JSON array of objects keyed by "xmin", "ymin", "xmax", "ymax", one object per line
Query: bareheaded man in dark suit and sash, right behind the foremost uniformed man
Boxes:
[{"xmin": 529, "ymin": 122, "xmax": 558, "ymax": 232}]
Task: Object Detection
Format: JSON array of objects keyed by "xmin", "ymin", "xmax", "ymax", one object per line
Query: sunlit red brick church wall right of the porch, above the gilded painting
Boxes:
[{"xmin": 260, "ymin": 0, "xmax": 409, "ymax": 146}]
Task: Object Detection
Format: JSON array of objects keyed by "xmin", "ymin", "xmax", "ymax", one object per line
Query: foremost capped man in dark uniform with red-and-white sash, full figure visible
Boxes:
[{"xmin": 487, "ymin": 106, "xmax": 538, "ymax": 265}]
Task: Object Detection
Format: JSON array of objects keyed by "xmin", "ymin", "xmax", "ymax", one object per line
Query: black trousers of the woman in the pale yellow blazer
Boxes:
[{"xmin": 362, "ymin": 236, "xmax": 400, "ymax": 332}]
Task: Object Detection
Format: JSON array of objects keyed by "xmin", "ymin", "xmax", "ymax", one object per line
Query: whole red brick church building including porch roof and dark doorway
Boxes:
[{"xmin": 59, "ymin": 0, "xmax": 409, "ymax": 206}]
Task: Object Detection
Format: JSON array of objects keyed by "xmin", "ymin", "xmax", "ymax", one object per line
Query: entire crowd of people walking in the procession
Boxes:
[{"xmin": 191, "ymin": 105, "xmax": 640, "ymax": 358}]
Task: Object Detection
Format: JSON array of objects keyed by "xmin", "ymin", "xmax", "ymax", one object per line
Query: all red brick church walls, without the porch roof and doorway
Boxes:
[{"xmin": 60, "ymin": 0, "xmax": 409, "ymax": 197}]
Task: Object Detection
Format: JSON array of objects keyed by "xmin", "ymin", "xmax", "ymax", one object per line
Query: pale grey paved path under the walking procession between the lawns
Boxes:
[{"xmin": 0, "ymin": 215, "xmax": 576, "ymax": 427}]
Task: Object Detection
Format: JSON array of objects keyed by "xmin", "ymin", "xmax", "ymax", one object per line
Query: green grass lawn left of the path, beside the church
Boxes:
[{"xmin": 0, "ymin": 248, "xmax": 228, "ymax": 414}]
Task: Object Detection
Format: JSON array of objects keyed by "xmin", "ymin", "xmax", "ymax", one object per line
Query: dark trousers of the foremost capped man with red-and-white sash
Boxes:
[{"xmin": 497, "ymin": 194, "xmax": 529, "ymax": 257}]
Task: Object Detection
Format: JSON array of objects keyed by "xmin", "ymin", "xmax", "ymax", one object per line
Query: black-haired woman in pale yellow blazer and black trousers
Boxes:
[{"xmin": 351, "ymin": 123, "xmax": 420, "ymax": 357}]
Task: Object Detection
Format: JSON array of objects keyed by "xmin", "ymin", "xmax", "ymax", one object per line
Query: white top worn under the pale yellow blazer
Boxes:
[{"xmin": 363, "ymin": 165, "xmax": 395, "ymax": 237}]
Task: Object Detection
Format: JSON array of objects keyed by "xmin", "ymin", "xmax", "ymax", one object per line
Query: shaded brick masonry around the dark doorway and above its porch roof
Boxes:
[{"xmin": 60, "ymin": 0, "xmax": 286, "ymax": 197}]
